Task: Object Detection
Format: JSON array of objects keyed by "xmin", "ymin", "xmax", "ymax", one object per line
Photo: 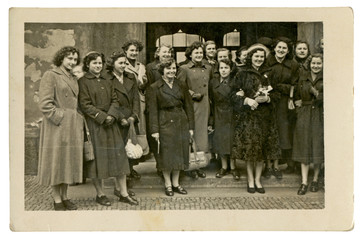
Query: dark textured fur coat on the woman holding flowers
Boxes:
[{"xmin": 231, "ymin": 66, "xmax": 281, "ymax": 161}]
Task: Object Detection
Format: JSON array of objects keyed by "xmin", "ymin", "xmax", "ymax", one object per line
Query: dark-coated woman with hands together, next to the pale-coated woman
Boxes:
[{"xmin": 79, "ymin": 52, "xmax": 138, "ymax": 206}]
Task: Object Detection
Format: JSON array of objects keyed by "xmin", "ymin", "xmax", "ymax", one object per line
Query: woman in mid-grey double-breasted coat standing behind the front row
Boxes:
[{"xmin": 177, "ymin": 42, "xmax": 212, "ymax": 178}]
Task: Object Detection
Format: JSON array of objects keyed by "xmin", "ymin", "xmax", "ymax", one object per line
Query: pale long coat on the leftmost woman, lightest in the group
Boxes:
[{"xmin": 37, "ymin": 67, "xmax": 84, "ymax": 186}]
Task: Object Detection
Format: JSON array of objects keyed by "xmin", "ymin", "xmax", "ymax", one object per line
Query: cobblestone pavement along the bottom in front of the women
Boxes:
[{"xmin": 25, "ymin": 176, "xmax": 324, "ymax": 211}]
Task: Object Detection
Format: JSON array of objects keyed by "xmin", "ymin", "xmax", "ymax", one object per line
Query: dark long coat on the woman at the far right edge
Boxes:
[{"xmin": 293, "ymin": 71, "xmax": 324, "ymax": 163}]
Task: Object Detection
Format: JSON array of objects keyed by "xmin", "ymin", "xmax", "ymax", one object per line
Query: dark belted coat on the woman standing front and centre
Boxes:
[{"xmin": 147, "ymin": 80, "xmax": 195, "ymax": 170}]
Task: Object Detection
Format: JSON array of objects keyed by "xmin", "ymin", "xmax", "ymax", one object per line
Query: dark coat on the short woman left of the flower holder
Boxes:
[{"xmin": 209, "ymin": 77, "xmax": 234, "ymax": 154}]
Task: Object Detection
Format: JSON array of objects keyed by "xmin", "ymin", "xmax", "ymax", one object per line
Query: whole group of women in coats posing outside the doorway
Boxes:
[{"xmin": 38, "ymin": 35, "xmax": 324, "ymax": 210}]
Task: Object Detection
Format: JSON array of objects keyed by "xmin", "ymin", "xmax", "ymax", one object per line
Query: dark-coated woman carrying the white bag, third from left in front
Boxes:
[{"xmin": 105, "ymin": 52, "xmax": 140, "ymax": 197}]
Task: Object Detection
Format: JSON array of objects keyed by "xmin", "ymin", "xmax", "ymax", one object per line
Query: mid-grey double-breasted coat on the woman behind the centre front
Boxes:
[{"xmin": 177, "ymin": 61, "xmax": 212, "ymax": 152}]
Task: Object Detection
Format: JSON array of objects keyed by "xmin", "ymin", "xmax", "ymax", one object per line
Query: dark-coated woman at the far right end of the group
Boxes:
[{"xmin": 293, "ymin": 54, "xmax": 324, "ymax": 195}]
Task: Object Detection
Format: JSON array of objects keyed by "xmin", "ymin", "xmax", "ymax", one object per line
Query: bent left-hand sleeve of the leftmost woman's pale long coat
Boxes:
[{"xmin": 39, "ymin": 72, "xmax": 64, "ymax": 125}]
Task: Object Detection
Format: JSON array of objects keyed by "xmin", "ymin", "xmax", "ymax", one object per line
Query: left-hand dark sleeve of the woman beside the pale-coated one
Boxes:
[{"xmin": 78, "ymin": 78, "xmax": 107, "ymax": 124}]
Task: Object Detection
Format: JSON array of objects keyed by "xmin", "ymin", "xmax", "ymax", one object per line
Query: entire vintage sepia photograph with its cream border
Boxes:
[{"xmin": 10, "ymin": 8, "xmax": 353, "ymax": 231}]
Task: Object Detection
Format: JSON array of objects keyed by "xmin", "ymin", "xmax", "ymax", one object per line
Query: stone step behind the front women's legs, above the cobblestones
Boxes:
[{"xmin": 103, "ymin": 159, "xmax": 312, "ymax": 189}]
